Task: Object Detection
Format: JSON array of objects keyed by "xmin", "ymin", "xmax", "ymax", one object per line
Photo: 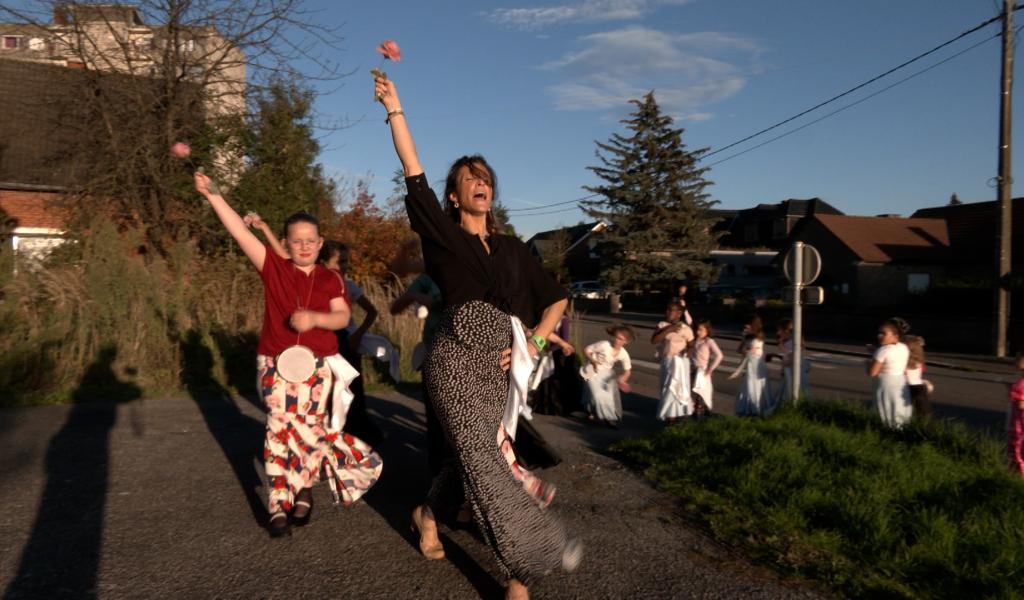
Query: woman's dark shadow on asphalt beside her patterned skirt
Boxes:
[{"xmin": 366, "ymin": 394, "xmax": 505, "ymax": 598}]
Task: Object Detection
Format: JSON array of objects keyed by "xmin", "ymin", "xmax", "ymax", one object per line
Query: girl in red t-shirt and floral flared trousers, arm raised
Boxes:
[{"xmin": 195, "ymin": 173, "xmax": 383, "ymax": 537}]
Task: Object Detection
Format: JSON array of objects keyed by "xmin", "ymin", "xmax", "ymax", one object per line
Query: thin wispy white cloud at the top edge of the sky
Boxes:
[{"xmin": 483, "ymin": 0, "xmax": 690, "ymax": 30}]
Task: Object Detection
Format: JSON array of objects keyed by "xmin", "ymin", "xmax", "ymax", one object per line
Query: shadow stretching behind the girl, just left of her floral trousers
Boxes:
[{"xmin": 181, "ymin": 331, "xmax": 267, "ymax": 525}]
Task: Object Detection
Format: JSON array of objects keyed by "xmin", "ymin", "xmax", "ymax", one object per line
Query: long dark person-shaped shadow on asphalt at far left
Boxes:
[{"xmin": 4, "ymin": 345, "xmax": 142, "ymax": 599}]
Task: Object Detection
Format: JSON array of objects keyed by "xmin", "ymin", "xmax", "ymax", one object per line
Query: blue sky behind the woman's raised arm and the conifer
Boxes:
[{"xmin": 317, "ymin": 0, "xmax": 1024, "ymax": 237}]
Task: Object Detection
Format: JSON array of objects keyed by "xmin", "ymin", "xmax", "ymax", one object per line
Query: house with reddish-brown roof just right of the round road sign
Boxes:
[{"xmin": 791, "ymin": 214, "xmax": 952, "ymax": 308}]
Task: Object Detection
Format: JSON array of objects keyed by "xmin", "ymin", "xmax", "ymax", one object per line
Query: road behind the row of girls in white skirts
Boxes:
[{"xmin": 573, "ymin": 315, "xmax": 1015, "ymax": 433}]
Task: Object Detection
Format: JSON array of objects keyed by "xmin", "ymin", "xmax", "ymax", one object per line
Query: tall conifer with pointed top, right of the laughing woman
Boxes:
[{"xmin": 583, "ymin": 92, "xmax": 718, "ymax": 289}]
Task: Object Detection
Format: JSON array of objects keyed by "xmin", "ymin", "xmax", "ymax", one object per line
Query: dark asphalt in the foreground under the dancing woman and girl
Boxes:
[{"xmin": 0, "ymin": 384, "xmax": 821, "ymax": 599}]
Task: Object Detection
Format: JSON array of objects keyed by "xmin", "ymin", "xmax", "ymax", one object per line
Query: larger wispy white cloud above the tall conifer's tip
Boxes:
[{"xmin": 540, "ymin": 27, "xmax": 761, "ymax": 121}]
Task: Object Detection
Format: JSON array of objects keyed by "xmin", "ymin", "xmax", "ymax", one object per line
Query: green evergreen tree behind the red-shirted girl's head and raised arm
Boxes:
[{"xmin": 231, "ymin": 81, "xmax": 335, "ymax": 234}]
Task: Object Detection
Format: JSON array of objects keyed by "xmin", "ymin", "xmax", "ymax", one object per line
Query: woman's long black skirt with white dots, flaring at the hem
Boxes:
[{"xmin": 423, "ymin": 301, "xmax": 567, "ymax": 586}]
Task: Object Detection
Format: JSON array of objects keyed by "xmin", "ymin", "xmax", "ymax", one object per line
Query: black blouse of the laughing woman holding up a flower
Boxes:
[{"xmin": 406, "ymin": 174, "xmax": 566, "ymax": 327}]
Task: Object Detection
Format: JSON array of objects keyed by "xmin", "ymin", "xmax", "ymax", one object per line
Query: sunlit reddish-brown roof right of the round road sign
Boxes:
[{"xmin": 814, "ymin": 215, "xmax": 950, "ymax": 263}]
